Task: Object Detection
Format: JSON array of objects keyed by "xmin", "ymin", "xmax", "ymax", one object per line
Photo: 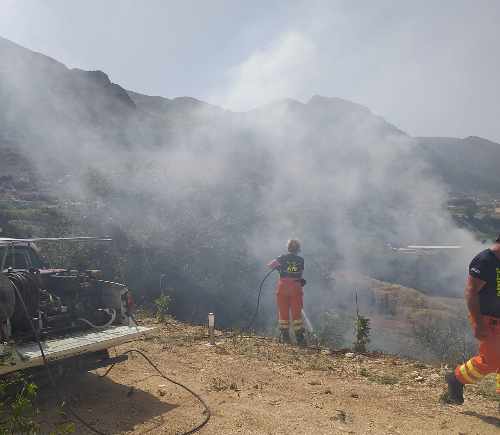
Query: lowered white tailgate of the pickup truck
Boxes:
[{"xmin": 0, "ymin": 326, "xmax": 154, "ymax": 375}]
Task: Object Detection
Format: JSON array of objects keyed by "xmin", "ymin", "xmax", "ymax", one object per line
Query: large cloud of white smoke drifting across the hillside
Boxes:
[{"xmin": 0, "ymin": 27, "xmax": 488, "ymax": 358}]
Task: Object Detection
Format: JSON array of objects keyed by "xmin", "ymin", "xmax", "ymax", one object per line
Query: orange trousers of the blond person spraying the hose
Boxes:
[{"xmin": 276, "ymin": 277, "xmax": 305, "ymax": 332}]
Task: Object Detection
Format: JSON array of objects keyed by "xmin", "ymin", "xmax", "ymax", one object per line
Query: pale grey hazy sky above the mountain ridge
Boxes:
[{"xmin": 0, "ymin": 0, "xmax": 500, "ymax": 142}]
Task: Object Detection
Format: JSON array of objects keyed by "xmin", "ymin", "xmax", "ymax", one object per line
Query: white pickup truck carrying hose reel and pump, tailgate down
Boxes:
[{"xmin": 0, "ymin": 237, "xmax": 152, "ymax": 382}]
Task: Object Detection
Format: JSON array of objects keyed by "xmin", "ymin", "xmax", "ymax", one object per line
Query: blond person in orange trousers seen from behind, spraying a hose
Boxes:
[{"xmin": 268, "ymin": 238, "xmax": 306, "ymax": 347}]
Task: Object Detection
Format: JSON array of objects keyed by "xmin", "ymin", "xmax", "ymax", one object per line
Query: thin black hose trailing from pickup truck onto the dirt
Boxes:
[{"xmin": 13, "ymin": 286, "xmax": 210, "ymax": 435}]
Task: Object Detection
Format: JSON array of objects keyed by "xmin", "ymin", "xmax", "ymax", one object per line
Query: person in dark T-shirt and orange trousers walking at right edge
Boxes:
[{"xmin": 445, "ymin": 236, "xmax": 500, "ymax": 412}]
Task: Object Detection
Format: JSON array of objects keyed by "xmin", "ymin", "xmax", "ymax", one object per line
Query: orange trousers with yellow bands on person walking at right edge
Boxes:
[{"xmin": 455, "ymin": 314, "xmax": 500, "ymax": 395}]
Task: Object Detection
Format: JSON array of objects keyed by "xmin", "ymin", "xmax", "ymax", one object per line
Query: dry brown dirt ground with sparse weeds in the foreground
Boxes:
[{"xmin": 36, "ymin": 321, "xmax": 500, "ymax": 435}]
